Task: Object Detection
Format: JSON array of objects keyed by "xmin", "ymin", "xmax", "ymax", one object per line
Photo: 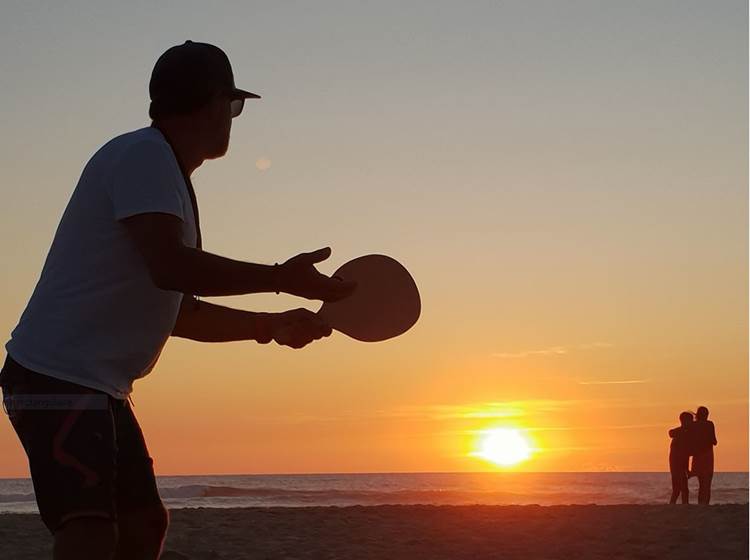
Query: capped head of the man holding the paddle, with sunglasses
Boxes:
[{"xmin": 148, "ymin": 40, "xmax": 260, "ymax": 166}]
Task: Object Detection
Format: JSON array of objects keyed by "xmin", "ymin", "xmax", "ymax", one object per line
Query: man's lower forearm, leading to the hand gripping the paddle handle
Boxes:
[{"xmin": 172, "ymin": 296, "xmax": 269, "ymax": 342}]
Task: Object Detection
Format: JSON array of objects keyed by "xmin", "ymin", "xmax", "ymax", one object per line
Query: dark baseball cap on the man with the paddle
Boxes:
[{"xmin": 148, "ymin": 40, "xmax": 260, "ymax": 117}]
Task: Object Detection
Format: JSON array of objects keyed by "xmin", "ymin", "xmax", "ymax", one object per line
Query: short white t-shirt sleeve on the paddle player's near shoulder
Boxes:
[{"xmin": 109, "ymin": 142, "xmax": 185, "ymax": 221}]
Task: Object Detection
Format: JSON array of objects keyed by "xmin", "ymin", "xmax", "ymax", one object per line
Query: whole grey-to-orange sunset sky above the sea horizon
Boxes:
[{"xmin": 0, "ymin": 0, "xmax": 748, "ymax": 477}]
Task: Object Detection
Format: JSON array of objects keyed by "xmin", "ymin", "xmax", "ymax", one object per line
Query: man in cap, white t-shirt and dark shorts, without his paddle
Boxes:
[{"xmin": 0, "ymin": 41, "xmax": 355, "ymax": 560}]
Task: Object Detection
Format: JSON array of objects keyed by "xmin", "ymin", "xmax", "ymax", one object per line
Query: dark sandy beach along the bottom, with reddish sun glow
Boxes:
[{"xmin": 0, "ymin": 505, "xmax": 748, "ymax": 560}]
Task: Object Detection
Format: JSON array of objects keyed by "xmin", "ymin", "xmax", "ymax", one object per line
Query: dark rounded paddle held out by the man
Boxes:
[{"xmin": 318, "ymin": 255, "xmax": 421, "ymax": 342}]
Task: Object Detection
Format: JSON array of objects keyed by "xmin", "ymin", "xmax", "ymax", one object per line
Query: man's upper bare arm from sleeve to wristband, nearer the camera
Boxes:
[{"xmin": 163, "ymin": 247, "xmax": 280, "ymax": 296}]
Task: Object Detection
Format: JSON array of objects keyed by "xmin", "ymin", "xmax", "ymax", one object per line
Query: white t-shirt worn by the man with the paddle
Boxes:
[{"xmin": 5, "ymin": 127, "xmax": 197, "ymax": 399}]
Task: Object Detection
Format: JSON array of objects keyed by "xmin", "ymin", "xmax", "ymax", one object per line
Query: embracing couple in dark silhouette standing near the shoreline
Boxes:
[{"xmin": 669, "ymin": 406, "xmax": 717, "ymax": 505}]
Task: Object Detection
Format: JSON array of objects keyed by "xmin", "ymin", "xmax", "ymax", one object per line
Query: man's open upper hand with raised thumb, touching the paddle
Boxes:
[{"xmin": 279, "ymin": 247, "xmax": 357, "ymax": 301}]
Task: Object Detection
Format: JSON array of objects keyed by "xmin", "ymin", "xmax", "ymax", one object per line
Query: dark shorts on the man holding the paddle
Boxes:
[{"xmin": 0, "ymin": 356, "xmax": 162, "ymax": 534}]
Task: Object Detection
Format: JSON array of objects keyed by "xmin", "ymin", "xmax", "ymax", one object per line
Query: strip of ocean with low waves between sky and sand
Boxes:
[{"xmin": 0, "ymin": 472, "xmax": 748, "ymax": 513}]
